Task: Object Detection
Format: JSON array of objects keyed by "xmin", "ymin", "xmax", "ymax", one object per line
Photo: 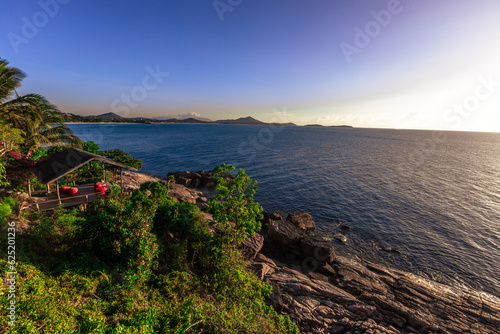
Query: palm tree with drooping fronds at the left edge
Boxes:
[{"xmin": 0, "ymin": 59, "xmax": 81, "ymax": 156}]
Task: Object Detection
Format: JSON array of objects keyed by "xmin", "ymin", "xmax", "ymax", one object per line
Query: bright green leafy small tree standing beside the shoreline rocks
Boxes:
[{"xmin": 209, "ymin": 164, "xmax": 263, "ymax": 243}]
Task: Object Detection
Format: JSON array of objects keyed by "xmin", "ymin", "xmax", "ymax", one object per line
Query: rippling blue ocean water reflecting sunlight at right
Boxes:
[{"xmin": 71, "ymin": 124, "xmax": 500, "ymax": 296}]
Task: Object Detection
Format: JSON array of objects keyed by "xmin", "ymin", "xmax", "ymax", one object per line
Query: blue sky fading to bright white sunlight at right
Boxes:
[{"xmin": 0, "ymin": 0, "xmax": 500, "ymax": 132}]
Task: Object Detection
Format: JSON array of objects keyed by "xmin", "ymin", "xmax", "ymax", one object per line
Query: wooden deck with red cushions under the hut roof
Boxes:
[{"xmin": 33, "ymin": 183, "xmax": 111, "ymax": 211}]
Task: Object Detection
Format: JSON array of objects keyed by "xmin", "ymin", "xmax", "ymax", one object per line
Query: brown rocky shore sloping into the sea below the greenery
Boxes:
[{"xmin": 122, "ymin": 172, "xmax": 500, "ymax": 334}]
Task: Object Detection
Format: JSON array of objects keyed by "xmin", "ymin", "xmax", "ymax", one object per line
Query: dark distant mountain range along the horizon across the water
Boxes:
[{"xmin": 62, "ymin": 112, "xmax": 352, "ymax": 128}]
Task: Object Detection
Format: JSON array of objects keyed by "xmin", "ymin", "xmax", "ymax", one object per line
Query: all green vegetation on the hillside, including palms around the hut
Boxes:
[{"xmin": 0, "ymin": 60, "xmax": 298, "ymax": 334}]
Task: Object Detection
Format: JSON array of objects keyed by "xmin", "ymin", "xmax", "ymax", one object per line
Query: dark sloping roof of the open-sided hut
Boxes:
[{"xmin": 34, "ymin": 148, "xmax": 137, "ymax": 183}]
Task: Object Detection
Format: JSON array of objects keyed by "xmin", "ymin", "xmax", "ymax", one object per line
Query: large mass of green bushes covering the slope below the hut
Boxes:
[{"xmin": 0, "ymin": 182, "xmax": 299, "ymax": 334}]
